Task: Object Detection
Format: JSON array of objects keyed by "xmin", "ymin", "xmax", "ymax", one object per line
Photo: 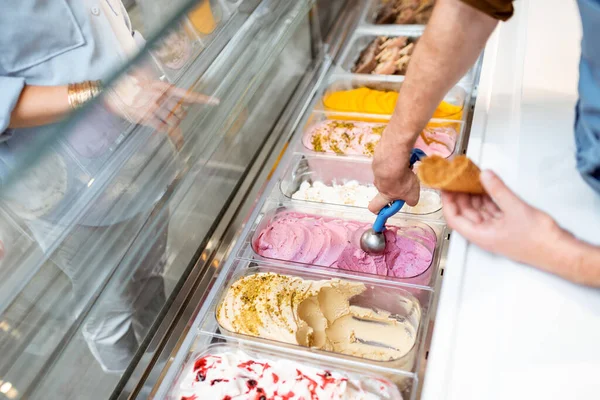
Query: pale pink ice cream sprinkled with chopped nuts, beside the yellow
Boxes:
[{"xmin": 302, "ymin": 120, "xmax": 458, "ymax": 157}]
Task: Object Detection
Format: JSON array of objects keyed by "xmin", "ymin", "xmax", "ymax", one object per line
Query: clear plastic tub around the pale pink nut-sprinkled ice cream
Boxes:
[{"xmin": 296, "ymin": 111, "xmax": 465, "ymax": 160}]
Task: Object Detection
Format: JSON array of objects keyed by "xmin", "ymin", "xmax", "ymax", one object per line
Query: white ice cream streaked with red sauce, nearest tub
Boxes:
[{"xmin": 176, "ymin": 351, "xmax": 402, "ymax": 400}]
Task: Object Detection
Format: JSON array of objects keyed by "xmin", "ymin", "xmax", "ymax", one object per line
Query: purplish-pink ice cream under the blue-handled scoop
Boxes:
[{"xmin": 253, "ymin": 212, "xmax": 436, "ymax": 278}]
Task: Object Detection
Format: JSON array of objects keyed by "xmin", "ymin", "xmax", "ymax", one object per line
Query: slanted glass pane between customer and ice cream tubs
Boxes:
[{"xmin": 0, "ymin": 0, "xmax": 318, "ymax": 399}]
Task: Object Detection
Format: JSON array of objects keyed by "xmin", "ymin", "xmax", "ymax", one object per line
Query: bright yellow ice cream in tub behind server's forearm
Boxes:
[{"xmin": 323, "ymin": 87, "xmax": 462, "ymax": 121}]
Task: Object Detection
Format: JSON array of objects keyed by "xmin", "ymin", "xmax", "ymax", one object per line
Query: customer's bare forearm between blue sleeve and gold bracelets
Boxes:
[{"xmin": 9, "ymin": 85, "xmax": 71, "ymax": 128}]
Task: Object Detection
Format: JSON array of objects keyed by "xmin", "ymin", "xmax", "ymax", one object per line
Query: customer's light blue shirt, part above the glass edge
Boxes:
[{"xmin": 0, "ymin": 0, "xmax": 130, "ymax": 132}]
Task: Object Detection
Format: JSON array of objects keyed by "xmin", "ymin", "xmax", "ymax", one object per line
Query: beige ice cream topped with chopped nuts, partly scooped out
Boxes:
[{"xmin": 217, "ymin": 273, "xmax": 416, "ymax": 361}]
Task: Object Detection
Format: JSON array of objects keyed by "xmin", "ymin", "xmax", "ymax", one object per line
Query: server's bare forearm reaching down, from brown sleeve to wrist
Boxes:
[{"xmin": 386, "ymin": 0, "xmax": 497, "ymax": 150}]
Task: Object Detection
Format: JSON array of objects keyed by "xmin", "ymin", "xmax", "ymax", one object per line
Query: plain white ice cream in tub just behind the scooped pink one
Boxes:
[{"xmin": 292, "ymin": 180, "xmax": 442, "ymax": 214}]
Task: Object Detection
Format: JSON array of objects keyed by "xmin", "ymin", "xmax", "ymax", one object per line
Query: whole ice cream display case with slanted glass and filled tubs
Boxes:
[{"xmin": 0, "ymin": 0, "xmax": 479, "ymax": 400}]
